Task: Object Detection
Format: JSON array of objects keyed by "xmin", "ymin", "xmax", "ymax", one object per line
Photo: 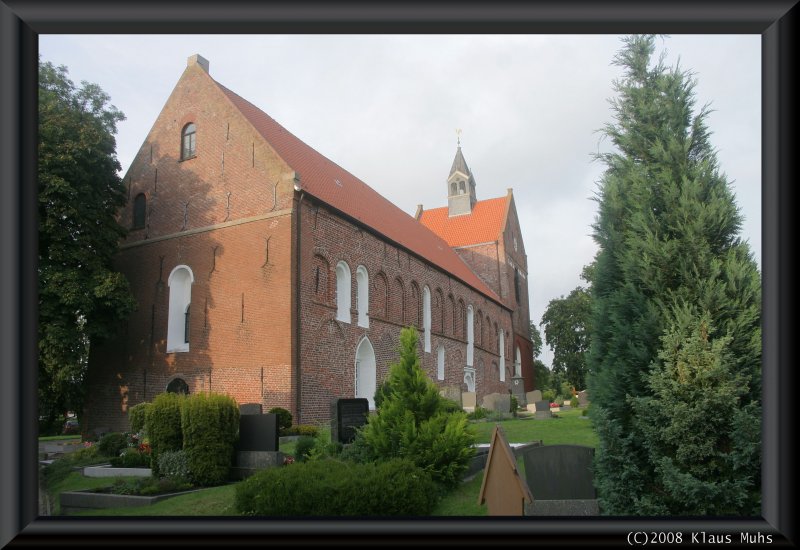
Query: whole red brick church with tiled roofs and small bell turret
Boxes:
[{"xmin": 84, "ymin": 55, "xmax": 533, "ymax": 430}]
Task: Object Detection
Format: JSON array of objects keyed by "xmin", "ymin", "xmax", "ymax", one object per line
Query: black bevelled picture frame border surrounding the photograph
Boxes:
[{"xmin": 0, "ymin": 0, "xmax": 798, "ymax": 547}]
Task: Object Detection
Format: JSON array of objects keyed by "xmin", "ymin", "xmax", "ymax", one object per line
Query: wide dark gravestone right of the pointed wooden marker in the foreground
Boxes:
[{"xmin": 522, "ymin": 445, "xmax": 597, "ymax": 500}]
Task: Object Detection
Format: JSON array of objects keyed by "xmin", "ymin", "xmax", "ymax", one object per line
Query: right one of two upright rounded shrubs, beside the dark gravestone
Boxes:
[{"xmin": 181, "ymin": 393, "xmax": 239, "ymax": 486}]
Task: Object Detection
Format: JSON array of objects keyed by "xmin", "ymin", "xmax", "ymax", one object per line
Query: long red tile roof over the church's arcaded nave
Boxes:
[{"xmin": 217, "ymin": 82, "xmax": 504, "ymax": 305}]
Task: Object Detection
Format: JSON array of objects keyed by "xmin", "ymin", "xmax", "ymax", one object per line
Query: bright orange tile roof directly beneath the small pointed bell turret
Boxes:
[{"xmin": 419, "ymin": 195, "xmax": 508, "ymax": 246}]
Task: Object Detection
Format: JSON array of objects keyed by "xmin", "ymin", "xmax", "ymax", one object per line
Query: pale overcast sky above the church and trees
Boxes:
[{"xmin": 39, "ymin": 35, "xmax": 761, "ymax": 366}]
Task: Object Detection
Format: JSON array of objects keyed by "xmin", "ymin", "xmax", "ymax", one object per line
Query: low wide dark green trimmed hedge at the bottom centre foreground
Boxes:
[{"xmin": 236, "ymin": 459, "xmax": 440, "ymax": 517}]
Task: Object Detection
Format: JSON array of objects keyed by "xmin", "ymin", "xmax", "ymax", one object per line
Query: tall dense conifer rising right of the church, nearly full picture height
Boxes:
[{"xmin": 588, "ymin": 35, "xmax": 761, "ymax": 515}]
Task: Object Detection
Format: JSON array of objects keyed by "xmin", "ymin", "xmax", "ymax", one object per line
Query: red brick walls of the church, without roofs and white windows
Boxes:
[{"xmin": 85, "ymin": 57, "xmax": 529, "ymax": 436}]
